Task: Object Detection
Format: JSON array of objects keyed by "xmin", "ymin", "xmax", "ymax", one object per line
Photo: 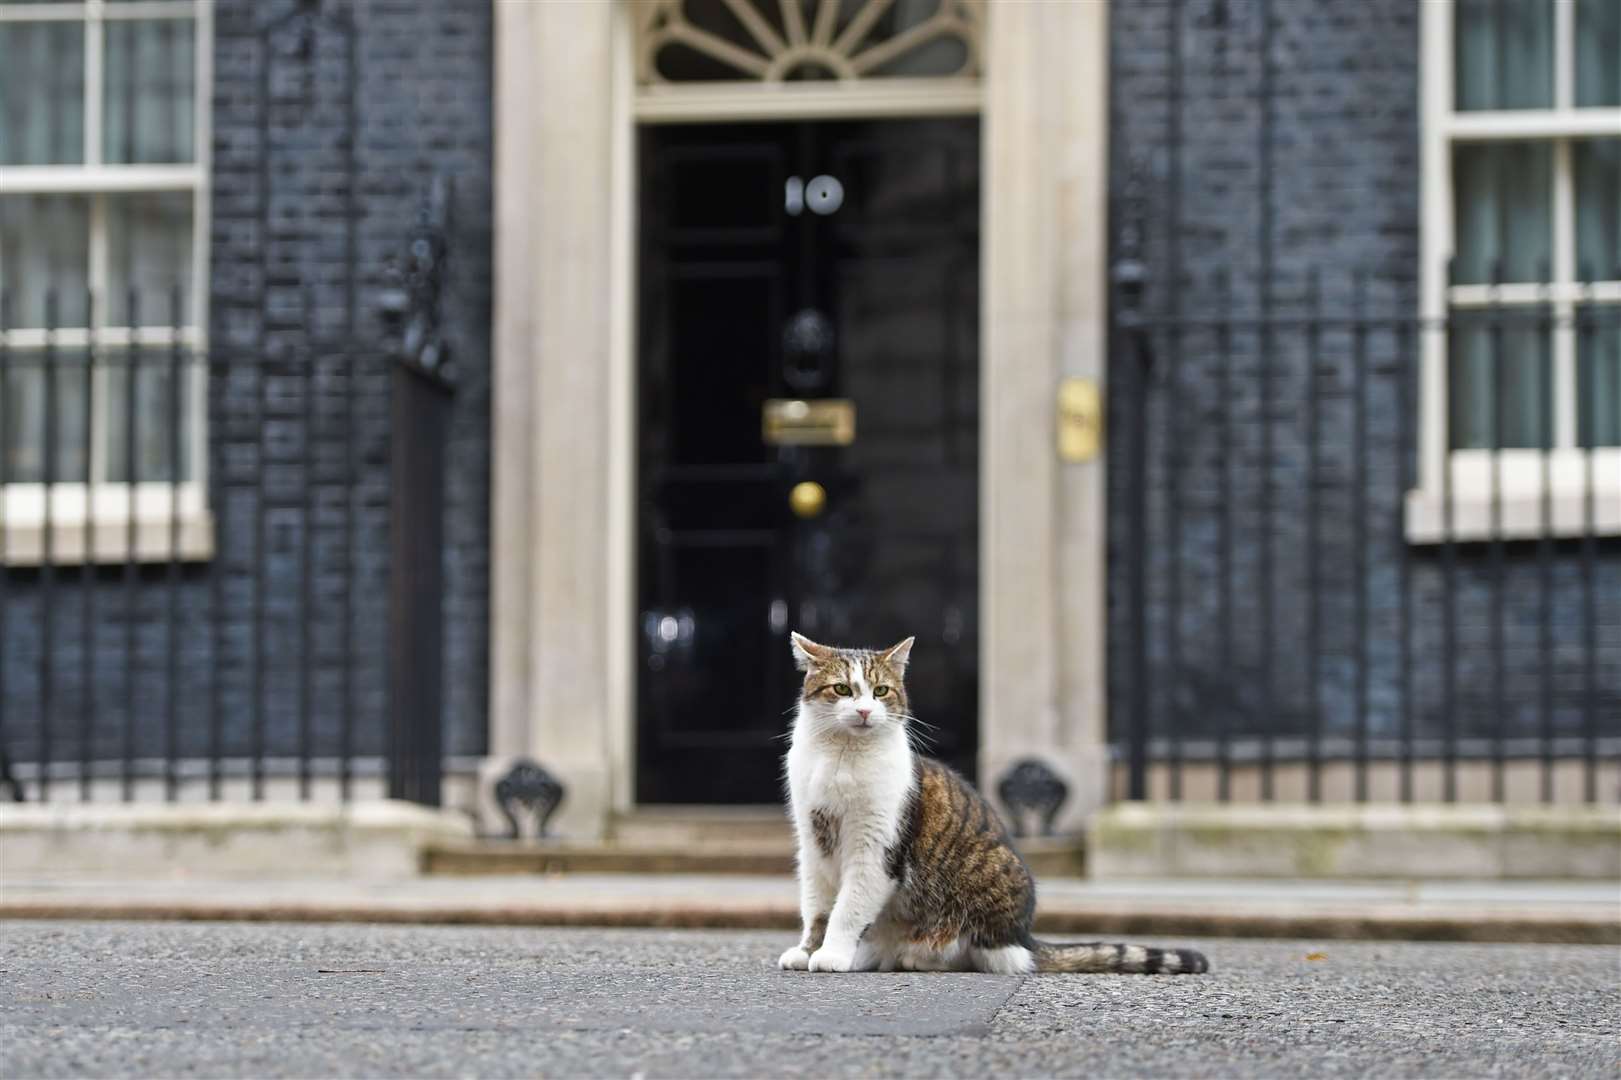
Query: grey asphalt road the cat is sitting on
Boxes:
[{"xmin": 0, "ymin": 921, "xmax": 1621, "ymax": 1080}]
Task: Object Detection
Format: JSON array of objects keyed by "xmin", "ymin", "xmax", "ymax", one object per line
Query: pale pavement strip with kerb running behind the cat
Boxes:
[{"xmin": 0, "ymin": 874, "xmax": 1621, "ymax": 944}]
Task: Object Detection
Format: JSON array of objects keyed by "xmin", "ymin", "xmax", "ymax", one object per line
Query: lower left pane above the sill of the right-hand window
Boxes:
[{"xmin": 1448, "ymin": 308, "xmax": 1553, "ymax": 449}]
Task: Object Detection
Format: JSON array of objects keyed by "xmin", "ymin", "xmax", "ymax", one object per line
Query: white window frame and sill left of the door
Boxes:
[{"xmin": 0, "ymin": 0, "xmax": 214, "ymax": 566}]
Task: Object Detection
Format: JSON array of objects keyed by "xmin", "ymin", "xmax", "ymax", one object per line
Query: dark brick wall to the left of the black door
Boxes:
[{"xmin": 0, "ymin": 0, "xmax": 491, "ymax": 775}]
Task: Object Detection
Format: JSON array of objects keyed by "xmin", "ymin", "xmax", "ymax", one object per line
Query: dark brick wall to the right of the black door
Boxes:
[{"xmin": 1109, "ymin": 0, "xmax": 1621, "ymax": 752}]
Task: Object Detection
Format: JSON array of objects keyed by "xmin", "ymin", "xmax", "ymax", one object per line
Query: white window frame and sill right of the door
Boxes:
[{"xmin": 1405, "ymin": 0, "xmax": 1621, "ymax": 543}]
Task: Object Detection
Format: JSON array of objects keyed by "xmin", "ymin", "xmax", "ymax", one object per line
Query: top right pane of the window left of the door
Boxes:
[{"xmin": 102, "ymin": 19, "xmax": 196, "ymax": 165}]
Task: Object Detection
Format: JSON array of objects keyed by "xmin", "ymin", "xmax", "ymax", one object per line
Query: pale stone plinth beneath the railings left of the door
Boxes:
[{"xmin": 0, "ymin": 799, "xmax": 472, "ymax": 879}]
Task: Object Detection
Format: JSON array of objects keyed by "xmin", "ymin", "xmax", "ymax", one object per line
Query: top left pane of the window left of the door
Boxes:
[{"xmin": 0, "ymin": 23, "xmax": 84, "ymax": 165}]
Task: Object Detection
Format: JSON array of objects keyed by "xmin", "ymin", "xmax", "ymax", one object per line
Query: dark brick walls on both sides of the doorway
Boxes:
[{"xmin": 0, "ymin": 0, "xmax": 1601, "ymax": 791}]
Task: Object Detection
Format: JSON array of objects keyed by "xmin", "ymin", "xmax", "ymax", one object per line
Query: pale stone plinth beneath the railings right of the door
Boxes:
[{"xmin": 1086, "ymin": 803, "xmax": 1621, "ymax": 881}]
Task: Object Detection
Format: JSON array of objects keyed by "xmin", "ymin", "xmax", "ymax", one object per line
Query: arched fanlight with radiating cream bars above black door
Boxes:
[{"xmin": 634, "ymin": 0, "xmax": 986, "ymax": 92}]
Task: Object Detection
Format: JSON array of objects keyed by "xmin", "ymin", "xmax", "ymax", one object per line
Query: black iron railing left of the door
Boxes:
[{"xmin": 0, "ymin": 277, "xmax": 447, "ymax": 803}]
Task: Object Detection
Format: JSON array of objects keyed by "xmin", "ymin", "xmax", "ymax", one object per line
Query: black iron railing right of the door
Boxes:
[{"xmin": 1110, "ymin": 274, "xmax": 1621, "ymax": 801}]
